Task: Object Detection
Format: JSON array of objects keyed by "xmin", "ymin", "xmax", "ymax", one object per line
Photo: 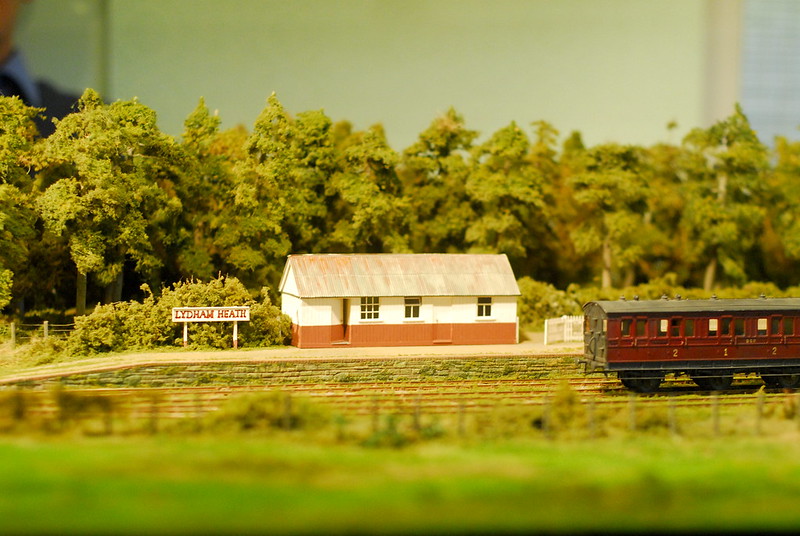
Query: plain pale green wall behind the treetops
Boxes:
[{"xmin": 18, "ymin": 0, "xmax": 776, "ymax": 150}]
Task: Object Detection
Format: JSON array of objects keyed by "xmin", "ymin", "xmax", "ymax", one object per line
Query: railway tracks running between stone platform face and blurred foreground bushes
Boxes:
[{"xmin": 5, "ymin": 370, "xmax": 787, "ymax": 421}]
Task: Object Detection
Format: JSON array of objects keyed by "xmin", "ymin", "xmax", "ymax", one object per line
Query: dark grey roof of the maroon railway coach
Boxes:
[{"xmin": 584, "ymin": 298, "xmax": 800, "ymax": 315}]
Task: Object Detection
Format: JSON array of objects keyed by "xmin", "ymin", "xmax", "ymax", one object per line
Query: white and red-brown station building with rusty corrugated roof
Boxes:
[{"xmin": 280, "ymin": 254, "xmax": 520, "ymax": 348}]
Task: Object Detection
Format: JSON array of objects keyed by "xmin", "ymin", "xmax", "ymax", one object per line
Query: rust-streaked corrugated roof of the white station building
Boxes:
[{"xmin": 280, "ymin": 254, "xmax": 519, "ymax": 298}]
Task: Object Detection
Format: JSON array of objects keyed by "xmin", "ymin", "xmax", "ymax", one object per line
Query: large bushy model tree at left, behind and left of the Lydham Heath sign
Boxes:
[{"xmin": 38, "ymin": 90, "xmax": 180, "ymax": 315}]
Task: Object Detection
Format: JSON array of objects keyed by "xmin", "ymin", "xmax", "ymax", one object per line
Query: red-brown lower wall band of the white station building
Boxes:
[{"xmin": 292, "ymin": 322, "xmax": 517, "ymax": 348}]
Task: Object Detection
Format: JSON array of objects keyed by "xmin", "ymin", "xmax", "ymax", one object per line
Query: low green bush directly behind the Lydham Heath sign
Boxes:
[{"xmin": 67, "ymin": 277, "xmax": 291, "ymax": 354}]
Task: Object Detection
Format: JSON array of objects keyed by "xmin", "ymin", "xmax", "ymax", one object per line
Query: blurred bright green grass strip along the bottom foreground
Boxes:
[{"xmin": 0, "ymin": 433, "xmax": 800, "ymax": 534}]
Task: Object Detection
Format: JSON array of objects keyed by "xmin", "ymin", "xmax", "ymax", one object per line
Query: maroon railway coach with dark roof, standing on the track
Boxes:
[{"xmin": 581, "ymin": 298, "xmax": 800, "ymax": 393}]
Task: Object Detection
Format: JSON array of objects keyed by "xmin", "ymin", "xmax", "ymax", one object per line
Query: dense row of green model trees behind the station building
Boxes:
[{"xmin": 6, "ymin": 90, "xmax": 800, "ymax": 318}]
